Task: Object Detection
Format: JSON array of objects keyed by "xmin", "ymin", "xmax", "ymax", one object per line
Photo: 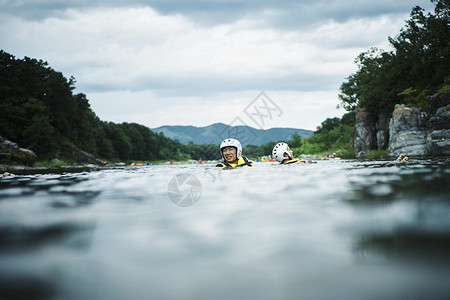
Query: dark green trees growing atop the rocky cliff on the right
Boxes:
[{"xmin": 339, "ymin": 0, "xmax": 450, "ymax": 112}]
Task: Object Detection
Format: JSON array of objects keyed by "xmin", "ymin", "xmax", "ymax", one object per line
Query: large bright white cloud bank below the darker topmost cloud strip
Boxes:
[{"xmin": 2, "ymin": 8, "xmax": 394, "ymax": 93}]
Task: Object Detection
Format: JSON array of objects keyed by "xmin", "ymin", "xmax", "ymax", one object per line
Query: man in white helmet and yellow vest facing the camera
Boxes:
[{"xmin": 216, "ymin": 139, "xmax": 254, "ymax": 168}]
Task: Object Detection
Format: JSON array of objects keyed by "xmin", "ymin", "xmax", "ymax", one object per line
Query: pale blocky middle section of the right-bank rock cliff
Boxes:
[{"xmin": 389, "ymin": 105, "xmax": 428, "ymax": 156}]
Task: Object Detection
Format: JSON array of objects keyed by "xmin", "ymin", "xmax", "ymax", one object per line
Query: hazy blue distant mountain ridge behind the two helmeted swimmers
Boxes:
[{"xmin": 152, "ymin": 123, "xmax": 313, "ymax": 147}]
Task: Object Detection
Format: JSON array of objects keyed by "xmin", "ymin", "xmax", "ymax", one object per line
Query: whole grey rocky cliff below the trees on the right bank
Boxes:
[{"xmin": 353, "ymin": 93, "xmax": 450, "ymax": 158}]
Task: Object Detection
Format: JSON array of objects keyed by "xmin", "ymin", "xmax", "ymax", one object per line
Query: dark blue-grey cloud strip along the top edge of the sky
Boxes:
[{"xmin": 0, "ymin": 0, "xmax": 432, "ymax": 29}]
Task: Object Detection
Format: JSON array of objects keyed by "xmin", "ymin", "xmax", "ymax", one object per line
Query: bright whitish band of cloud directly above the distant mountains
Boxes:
[{"xmin": 87, "ymin": 90, "xmax": 344, "ymax": 130}]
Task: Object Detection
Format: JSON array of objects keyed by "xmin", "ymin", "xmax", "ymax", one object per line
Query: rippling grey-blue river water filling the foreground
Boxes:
[{"xmin": 0, "ymin": 159, "xmax": 450, "ymax": 299}]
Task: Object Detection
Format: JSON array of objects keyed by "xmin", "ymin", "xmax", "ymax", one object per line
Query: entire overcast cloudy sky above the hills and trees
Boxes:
[{"xmin": 0, "ymin": 0, "xmax": 433, "ymax": 130}]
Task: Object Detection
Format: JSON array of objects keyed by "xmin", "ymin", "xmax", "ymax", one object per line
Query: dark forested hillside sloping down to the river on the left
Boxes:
[{"xmin": 0, "ymin": 51, "xmax": 189, "ymax": 164}]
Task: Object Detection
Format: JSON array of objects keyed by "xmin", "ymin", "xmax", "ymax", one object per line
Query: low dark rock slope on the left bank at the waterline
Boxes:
[{"xmin": 0, "ymin": 136, "xmax": 36, "ymax": 166}]
